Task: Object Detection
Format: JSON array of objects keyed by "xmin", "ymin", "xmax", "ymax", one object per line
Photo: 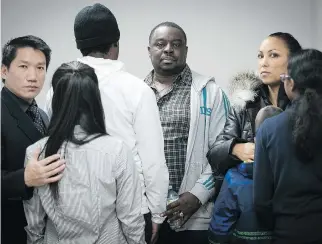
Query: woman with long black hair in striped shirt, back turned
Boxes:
[{"xmin": 24, "ymin": 62, "xmax": 144, "ymax": 244}]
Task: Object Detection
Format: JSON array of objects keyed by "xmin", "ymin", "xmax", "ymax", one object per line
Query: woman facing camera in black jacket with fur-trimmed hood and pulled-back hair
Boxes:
[{"xmin": 207, "ymin": 32, "xmax": 302, "ymax": 194}]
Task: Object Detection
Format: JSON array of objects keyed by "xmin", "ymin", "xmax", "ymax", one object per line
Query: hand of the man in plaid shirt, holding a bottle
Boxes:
[{"xmin": 162, "ymin": 192, "xmax": 201, "ymax": 226}]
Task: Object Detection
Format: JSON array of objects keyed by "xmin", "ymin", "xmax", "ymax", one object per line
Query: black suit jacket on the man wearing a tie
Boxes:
[{"xmin": 1, "ymin": 88, "xmax": 49, "ymax": 244}]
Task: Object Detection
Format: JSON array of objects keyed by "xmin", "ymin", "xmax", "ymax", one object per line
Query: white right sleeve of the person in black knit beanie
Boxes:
[{"xmin": 134, "ymin": 87, "xmax": 169, "ymax": 224}]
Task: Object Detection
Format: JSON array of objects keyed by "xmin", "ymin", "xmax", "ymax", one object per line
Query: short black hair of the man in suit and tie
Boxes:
[{"xmin": 2, "ymin": 35, "xmax": 51, "ymax": 82}]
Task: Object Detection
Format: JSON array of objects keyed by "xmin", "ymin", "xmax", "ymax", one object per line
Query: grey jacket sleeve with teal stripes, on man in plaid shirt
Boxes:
[{"xmin": 190, "ymin": 87, "xmax": 229, "ymax": 204}]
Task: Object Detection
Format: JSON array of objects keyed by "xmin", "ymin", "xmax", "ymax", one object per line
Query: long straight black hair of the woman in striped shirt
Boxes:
[{"xmin": 44, "ymin": 61, "xmax": 107, "ymax": 199}]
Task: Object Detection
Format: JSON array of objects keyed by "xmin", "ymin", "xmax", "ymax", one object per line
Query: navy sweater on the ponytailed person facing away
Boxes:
[{"xmin": 254, "ymin": 108, "xmax": 322, "ymax": 244}]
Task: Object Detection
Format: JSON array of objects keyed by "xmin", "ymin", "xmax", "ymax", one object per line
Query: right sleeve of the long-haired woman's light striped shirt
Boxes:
[{"xmin": 116, "ymin": 145, "xmax": 145, "ymax": 244}]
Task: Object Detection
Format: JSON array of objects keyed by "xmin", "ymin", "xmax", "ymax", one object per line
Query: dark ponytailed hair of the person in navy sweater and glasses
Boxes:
[{"xmin": 288, "ymin": 49, "xmax": 322, "ymax": 162}]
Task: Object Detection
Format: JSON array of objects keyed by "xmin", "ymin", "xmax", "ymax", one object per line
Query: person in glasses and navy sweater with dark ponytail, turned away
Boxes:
[{"xmin": 254, "ymin": 49, "xmax": 322, "ymax": 244}]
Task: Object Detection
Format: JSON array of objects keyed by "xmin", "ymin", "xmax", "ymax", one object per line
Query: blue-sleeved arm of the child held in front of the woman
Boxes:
[{"xmin": 210, "ymin": 171, "xmax": 240, "ymax": 243}]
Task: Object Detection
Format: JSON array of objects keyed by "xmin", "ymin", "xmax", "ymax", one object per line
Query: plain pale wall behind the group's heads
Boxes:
[{"xmin": 1, "ymin": 0, "xmax": 322, "ymax": 106}]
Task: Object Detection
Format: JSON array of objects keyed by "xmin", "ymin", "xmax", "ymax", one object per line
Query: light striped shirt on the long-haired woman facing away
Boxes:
[{"xmin": 24, "ymin": 127, "xmax": 145, "ymax": 244}]
